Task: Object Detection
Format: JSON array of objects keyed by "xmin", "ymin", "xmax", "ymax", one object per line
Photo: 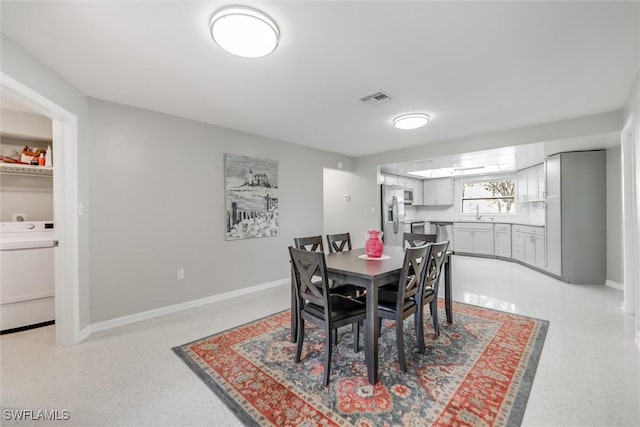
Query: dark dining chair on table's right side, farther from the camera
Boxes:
[{"xmin": 415, "ymin": 240, "xmax": 449, "ymax": 354}]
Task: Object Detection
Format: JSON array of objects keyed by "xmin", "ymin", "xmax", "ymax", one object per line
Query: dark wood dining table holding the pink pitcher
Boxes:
[{"xmin": 291, "ymin": 246, "xmax": 453, "ymax": 384}]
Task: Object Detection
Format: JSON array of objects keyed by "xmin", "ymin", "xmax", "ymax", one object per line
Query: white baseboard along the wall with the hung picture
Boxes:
[{"xmin": 80, "ymin": 278, "xmax": 291, "ymax": 341}]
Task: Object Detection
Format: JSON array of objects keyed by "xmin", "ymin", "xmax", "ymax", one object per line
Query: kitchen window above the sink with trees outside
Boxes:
[{"xmin": 462, "ymin": 178, "xmax": 516, "ymax": 214}]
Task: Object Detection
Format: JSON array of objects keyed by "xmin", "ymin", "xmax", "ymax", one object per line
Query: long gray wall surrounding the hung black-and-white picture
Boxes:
[{"xmin": 89, "ymin": 99, "xmax": 352, "ymax": 323}]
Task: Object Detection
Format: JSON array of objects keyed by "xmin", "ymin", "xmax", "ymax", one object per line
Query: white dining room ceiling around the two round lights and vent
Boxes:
[{"xmin": 1, "ymin": 0, "xmax": 640, "ymax": 156}]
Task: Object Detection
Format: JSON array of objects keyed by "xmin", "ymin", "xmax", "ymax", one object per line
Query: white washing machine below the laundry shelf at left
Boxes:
[{"xmin": 0, "ymin": 221, "xmax": 55, "ymax": 333}]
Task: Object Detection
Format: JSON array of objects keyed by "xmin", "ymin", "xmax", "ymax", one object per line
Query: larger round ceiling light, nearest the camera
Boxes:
[{"xmin": 209, "ymin": 6, "xmax": 280, "ymax": 58}]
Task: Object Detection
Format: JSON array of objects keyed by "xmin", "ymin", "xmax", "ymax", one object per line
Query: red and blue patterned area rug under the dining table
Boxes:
[{"xmin": 173, "ymin": 301, "xmax": 549, "ymax": 427}]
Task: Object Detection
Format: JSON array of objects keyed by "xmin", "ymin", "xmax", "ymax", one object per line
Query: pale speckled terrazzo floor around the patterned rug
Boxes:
[{"xmin": 0, "ymin": 257, "xmax": 640, "ymax": 426}]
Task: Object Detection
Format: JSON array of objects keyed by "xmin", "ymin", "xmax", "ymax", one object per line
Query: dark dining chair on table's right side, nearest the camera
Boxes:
[{"xmin": 378, "ymin": 244, "xmax": 431, "ymax": 372}]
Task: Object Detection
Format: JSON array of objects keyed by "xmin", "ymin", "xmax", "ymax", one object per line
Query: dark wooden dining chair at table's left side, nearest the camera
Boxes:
[{"xmin": 289, "ymin": 246, "xmax": 367, "ymax": 387}]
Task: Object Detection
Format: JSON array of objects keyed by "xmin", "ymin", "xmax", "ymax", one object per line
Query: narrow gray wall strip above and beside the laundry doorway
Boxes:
[{"xmin": 0, "ymin": 33, "xmax": 90, "ymax": 329}]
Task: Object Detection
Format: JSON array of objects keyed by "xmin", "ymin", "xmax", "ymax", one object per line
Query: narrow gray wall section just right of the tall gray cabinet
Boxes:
[{"xmin": 606, "ymin": 147, "xmax": 623, "ymax": 284}]
